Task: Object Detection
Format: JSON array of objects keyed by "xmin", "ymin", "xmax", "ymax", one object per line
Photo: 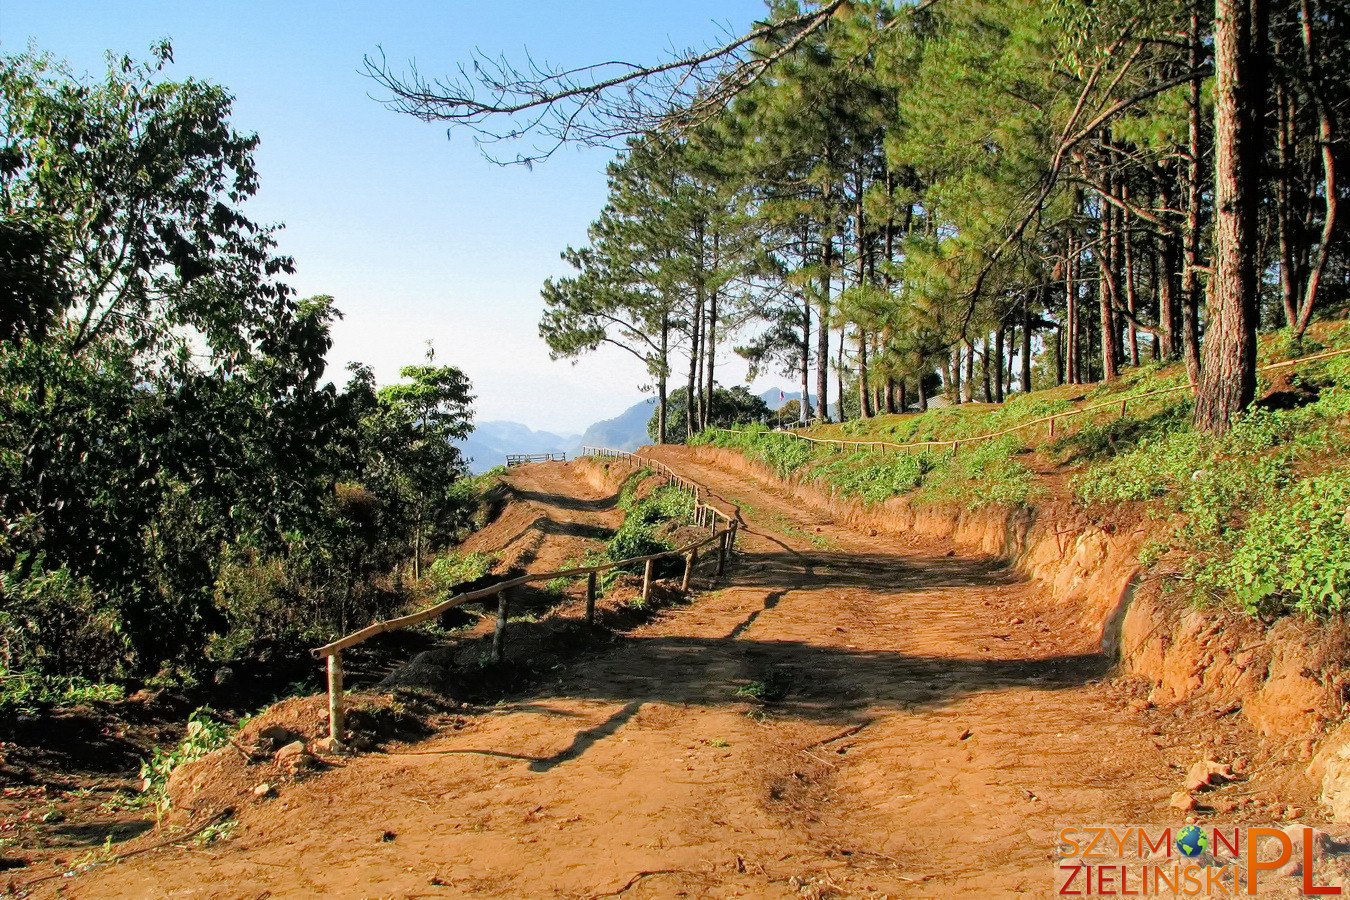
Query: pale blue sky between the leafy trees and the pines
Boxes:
[{"xmin": 0, "ymin": 0, "xmax": 764, "ymax": 432}]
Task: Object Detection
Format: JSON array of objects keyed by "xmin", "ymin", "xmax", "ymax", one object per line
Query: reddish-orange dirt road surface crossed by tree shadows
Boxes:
[{"xmin": 45, "ymin": 449, "xmax": 1296, "ymax": 897}]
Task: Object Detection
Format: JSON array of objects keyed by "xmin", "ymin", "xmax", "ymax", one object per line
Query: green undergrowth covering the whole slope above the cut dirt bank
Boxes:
[{"xmin": 695, "ymin": 322, "xmax": 1350, "ymax": 618}]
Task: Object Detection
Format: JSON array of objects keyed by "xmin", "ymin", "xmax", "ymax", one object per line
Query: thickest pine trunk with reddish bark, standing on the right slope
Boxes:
[{"xmin": 1195, "ymin": 0, "xmax": 1266, "ymax": 434}]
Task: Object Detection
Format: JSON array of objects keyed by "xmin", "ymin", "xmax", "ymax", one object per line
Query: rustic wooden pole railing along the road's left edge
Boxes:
[{"xmin": 312, "ymin": 447, "xmax": 740, "ymax": 742}]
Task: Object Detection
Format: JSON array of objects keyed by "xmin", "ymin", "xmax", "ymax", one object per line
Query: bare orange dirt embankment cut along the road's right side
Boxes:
[{"xmin": 684, "ymin": 447, "xmax": 1350, "ymax": 776}]
